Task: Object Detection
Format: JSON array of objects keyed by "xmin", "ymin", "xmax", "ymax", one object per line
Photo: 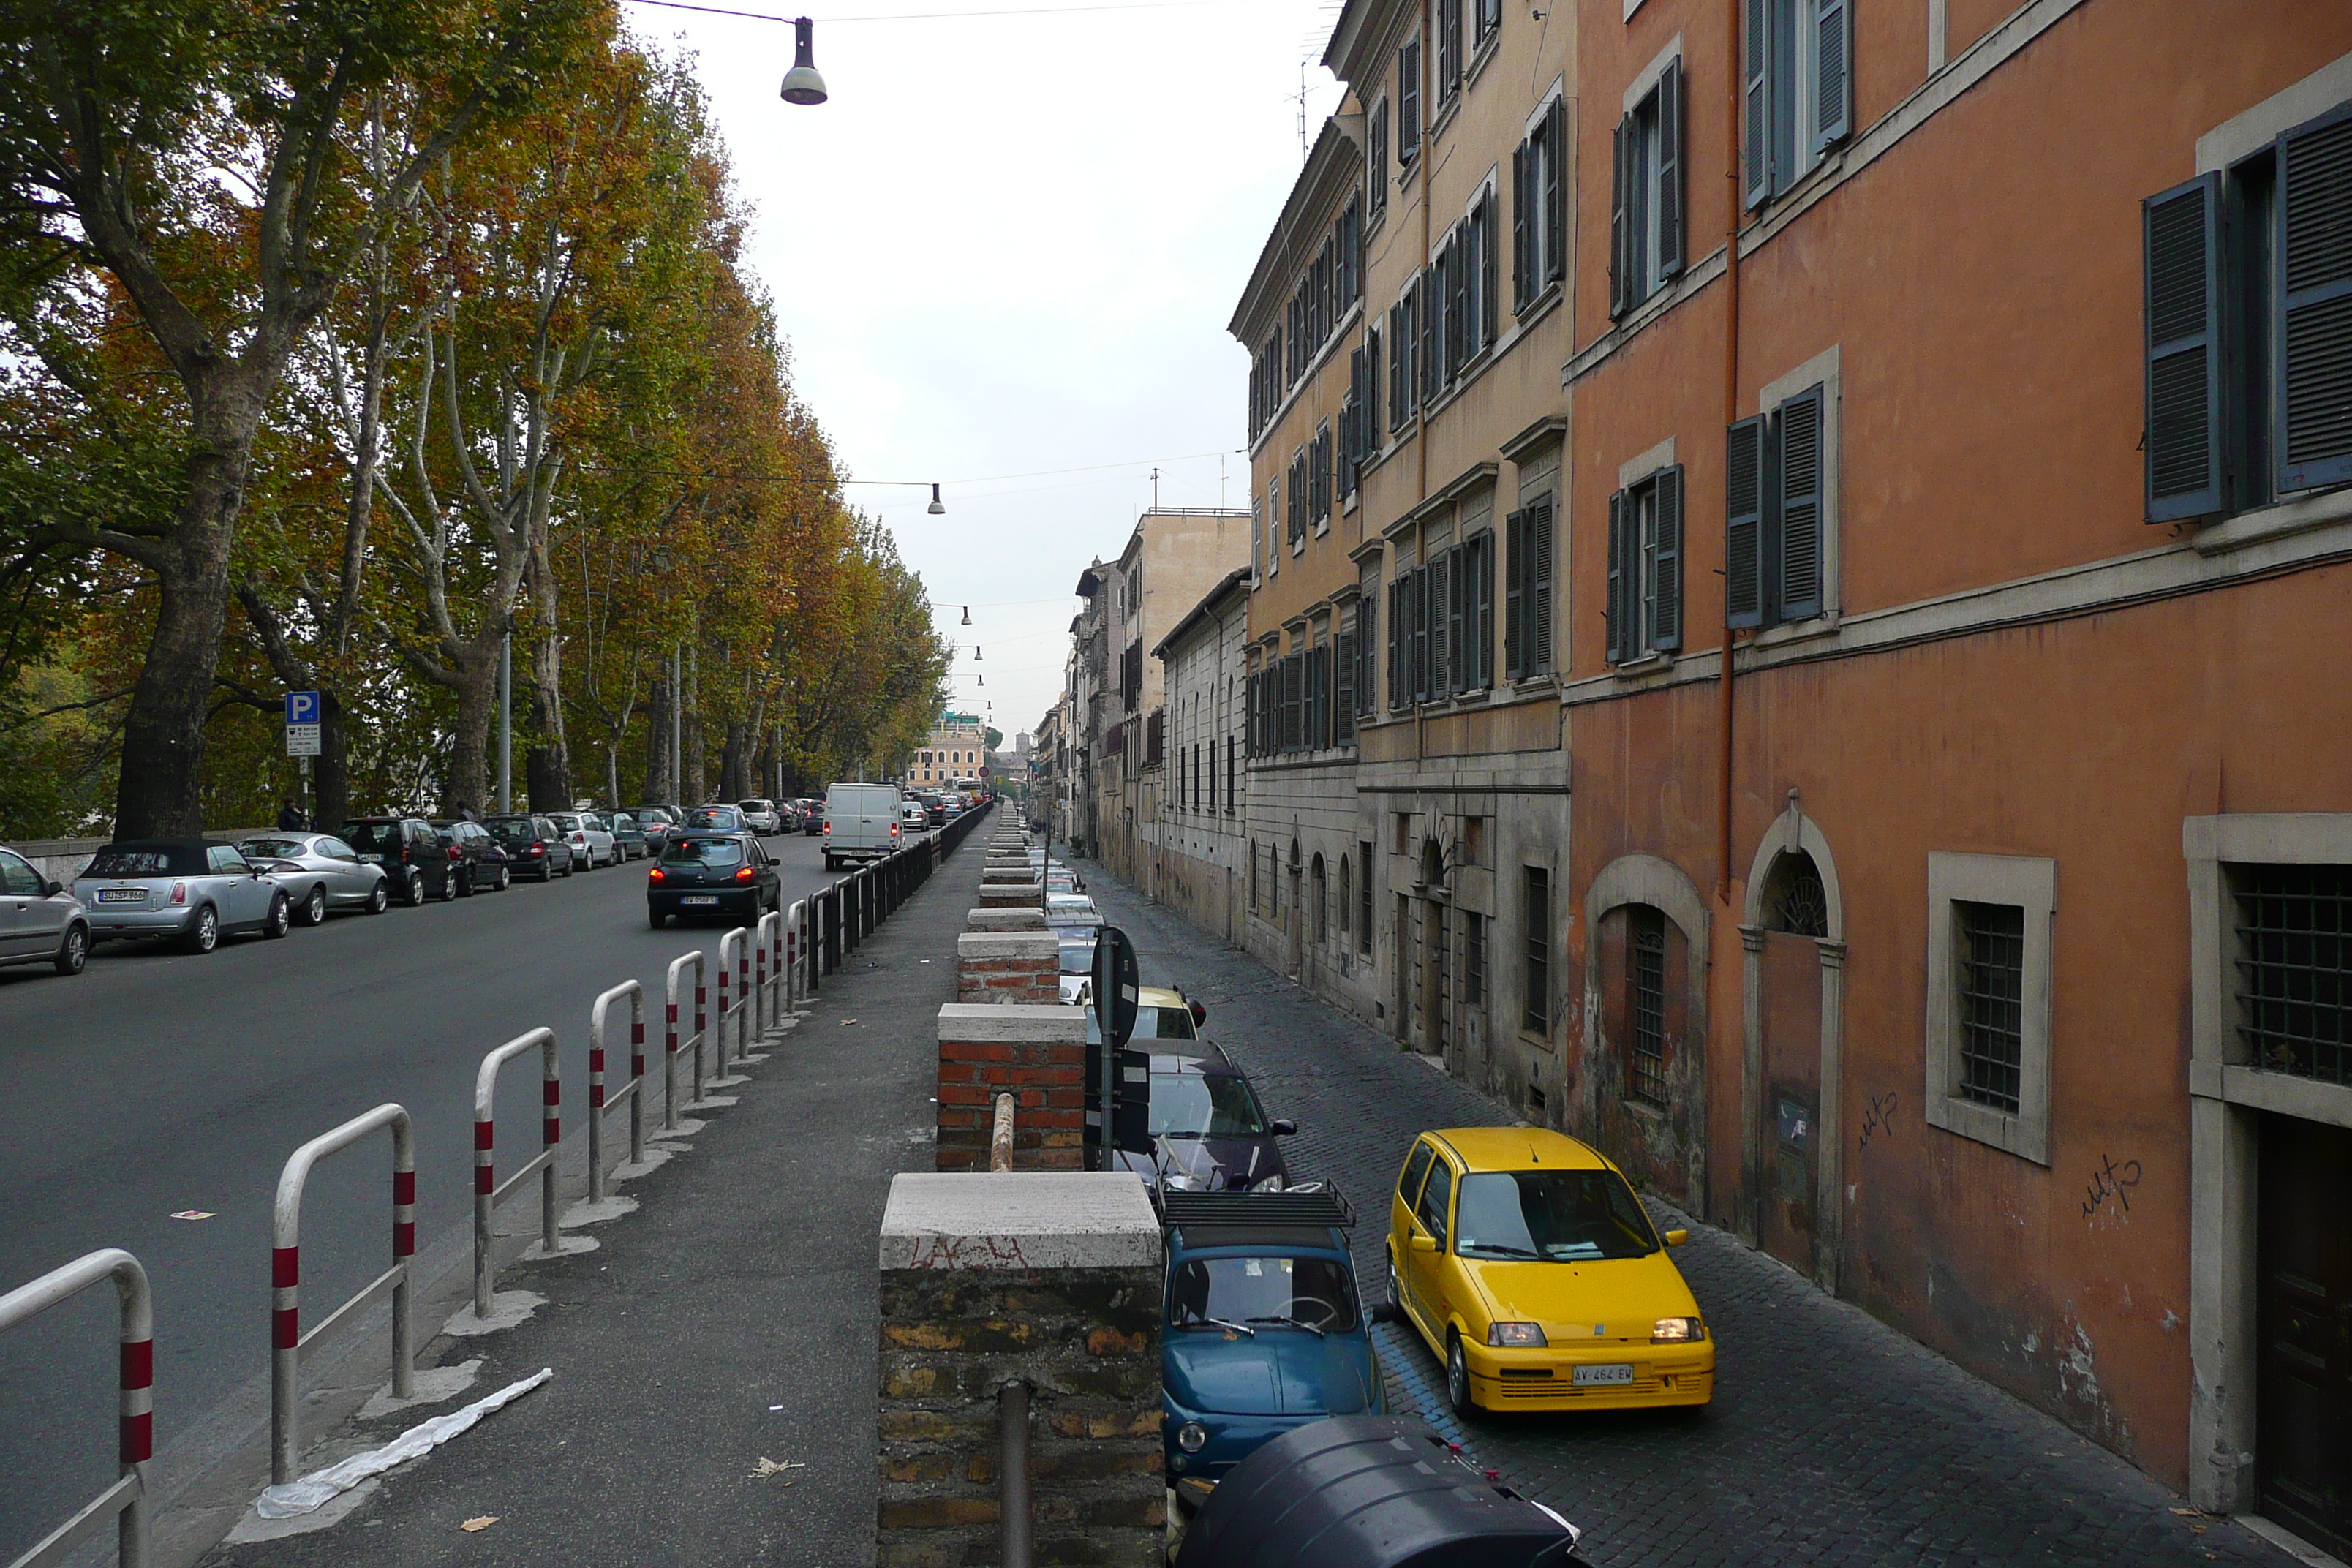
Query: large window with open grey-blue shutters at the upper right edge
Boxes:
[{"xmin": 2143, "ymin": 103, "xmax": 2352, "ymax": 522}]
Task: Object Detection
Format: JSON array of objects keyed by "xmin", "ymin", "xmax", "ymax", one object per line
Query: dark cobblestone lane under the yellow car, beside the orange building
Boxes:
[{"xmin": 1082, "ymin": 863, "xmax": 2293, "ymax": 1568}]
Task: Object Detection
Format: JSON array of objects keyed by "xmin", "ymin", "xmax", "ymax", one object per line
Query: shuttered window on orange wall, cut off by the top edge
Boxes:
[{"xmin": 1743, "ymin": 0, "xmax": 1853, "ymax": 207}]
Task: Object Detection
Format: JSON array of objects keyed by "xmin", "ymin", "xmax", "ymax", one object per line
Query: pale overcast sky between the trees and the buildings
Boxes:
[{"xmin": 623, "ymin": 0, "xmax": 1338, "ymax": 745}]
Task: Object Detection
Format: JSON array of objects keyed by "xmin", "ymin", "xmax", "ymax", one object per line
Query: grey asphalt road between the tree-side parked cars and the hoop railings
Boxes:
[{"xmin": 0, "ymin": 837, "xmax": 875, "ymax": 1561}]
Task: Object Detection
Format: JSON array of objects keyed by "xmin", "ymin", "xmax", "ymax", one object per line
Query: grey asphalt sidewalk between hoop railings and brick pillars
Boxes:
[{"xmin": 205, "ymin": 848, "xmax": 986, "ymax": 1568}]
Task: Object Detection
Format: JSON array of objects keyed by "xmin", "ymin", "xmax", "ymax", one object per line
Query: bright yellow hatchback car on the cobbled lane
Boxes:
[{"xmin": 1387, "ymin": 1126, "xmax": 1714, "ymax": 1420}]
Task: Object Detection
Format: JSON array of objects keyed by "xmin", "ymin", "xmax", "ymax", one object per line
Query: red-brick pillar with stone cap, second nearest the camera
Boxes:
[{"xmin": 934, "ymin": 1011, "xmax": 1087, "ymax": 1171}]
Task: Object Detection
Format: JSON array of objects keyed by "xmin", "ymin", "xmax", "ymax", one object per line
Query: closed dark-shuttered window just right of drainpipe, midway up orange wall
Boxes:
[{"xmin": 1724, "ymin": 385, "xmax": 1828, "ymax": 625}]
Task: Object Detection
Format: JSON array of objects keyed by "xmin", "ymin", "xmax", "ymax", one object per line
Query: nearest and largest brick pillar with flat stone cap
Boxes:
[{"xmin": 875, "ymin": 1173, "xmax": 1166, "ymax": 1568}]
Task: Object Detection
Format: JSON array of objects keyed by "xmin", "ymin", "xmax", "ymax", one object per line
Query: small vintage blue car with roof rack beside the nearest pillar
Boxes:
[{"xmin": 1159, "ymin": 1189, "xmax": 1387, "ymax": 1495}]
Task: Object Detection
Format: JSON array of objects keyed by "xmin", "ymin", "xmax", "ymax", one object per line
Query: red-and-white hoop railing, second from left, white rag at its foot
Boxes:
[{"xmin": 271, "ymin": 1103, "xmax": 416, "ymax": 1485}]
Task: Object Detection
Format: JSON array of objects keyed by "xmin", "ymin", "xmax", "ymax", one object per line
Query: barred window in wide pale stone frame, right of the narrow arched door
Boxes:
[{"xmin": 1926, "ymin": 853, "xmax": 2058, "ymax": 1166}]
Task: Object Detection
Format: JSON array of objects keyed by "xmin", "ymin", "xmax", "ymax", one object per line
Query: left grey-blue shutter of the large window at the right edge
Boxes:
[{"xmin": 2141, "ymin": 174, "xmax": 2223, "ymax": 522}]
